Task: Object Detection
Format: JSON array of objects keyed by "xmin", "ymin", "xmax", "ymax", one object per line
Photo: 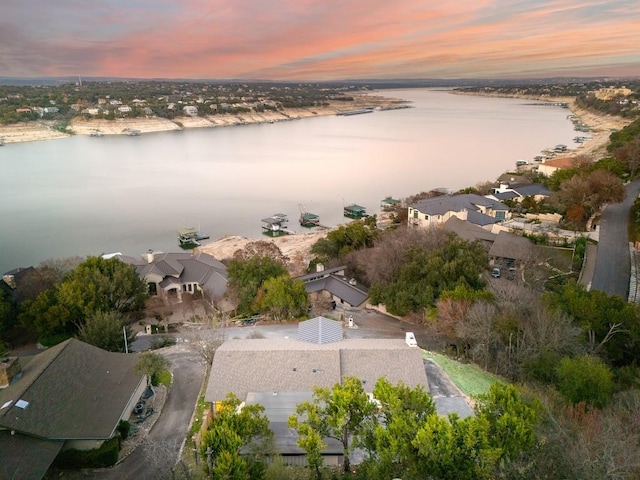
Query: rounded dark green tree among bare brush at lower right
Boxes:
[{"xmin": 557, "ymin": 355, "xmax": 613, "ymax": 408}]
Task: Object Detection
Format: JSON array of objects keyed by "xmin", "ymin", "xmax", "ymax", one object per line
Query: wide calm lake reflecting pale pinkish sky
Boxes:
[{"xmin": 0, "ymin": 89, "xmax": 576, "ymax": 272}]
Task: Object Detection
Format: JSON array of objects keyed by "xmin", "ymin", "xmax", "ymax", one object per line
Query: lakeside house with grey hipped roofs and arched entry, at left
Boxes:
[{"xmin": 117, "ymin": 250, "xmax": 227, "ymax": 302}]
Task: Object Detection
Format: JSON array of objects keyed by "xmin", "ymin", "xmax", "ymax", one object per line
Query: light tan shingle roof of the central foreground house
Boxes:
[{"xmin": 205, "ymin": 339, "xmax": 427, "ymax": 402}]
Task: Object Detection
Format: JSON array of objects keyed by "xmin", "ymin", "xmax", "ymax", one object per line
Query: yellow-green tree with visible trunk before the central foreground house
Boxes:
[{"xmin": 289, "ymin": 377, "xmax": 375, "ymax": 472}]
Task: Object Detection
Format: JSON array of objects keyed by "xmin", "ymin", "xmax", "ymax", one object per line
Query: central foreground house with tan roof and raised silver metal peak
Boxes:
[{"xmin": 205, "ymin": 317, "xmax": 428, "ymax": 465}]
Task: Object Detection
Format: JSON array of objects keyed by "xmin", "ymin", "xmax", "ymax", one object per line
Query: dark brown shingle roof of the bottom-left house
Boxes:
[{"xmin": 0, "ymin": 339, "xmax": 143, "ymax": 440}]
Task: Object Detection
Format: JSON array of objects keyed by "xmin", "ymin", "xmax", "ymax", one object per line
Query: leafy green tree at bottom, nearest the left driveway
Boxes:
[{"xmin": 200, "ymin": 393, "xmax": 273, "ymax": 479}]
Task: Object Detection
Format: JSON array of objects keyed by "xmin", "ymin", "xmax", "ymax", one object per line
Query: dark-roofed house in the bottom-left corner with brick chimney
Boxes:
[{"xmin": 0, "ymin": 339, "xmax": 147, "ymax": 479}]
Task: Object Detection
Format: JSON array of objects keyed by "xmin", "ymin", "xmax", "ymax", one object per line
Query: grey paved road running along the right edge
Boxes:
[{"xmin": 591, "ymin": 181, "xmax": 640, "ymax": 300}]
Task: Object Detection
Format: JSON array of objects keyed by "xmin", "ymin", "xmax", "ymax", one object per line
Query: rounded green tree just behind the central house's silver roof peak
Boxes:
[{"xmin": 254, "ymin": 275, "xmax": 309, "ymax": 321}]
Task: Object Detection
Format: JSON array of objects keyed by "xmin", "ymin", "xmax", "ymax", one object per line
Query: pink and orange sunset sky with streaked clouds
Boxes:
[{"xmin": 0, "ymin": 0, "xmax": 640, "ymax": 81}]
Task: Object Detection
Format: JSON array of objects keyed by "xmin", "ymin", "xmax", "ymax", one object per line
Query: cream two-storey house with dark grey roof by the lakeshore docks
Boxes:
[{"xmin": 408, "ymin": 194, "xmax": 511, "ymax": 230}]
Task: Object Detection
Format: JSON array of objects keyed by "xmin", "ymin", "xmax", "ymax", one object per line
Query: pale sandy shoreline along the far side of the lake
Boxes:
[{"xmin": 0, "ymin": 92, "xmax": 410, "ymax": 145}]
